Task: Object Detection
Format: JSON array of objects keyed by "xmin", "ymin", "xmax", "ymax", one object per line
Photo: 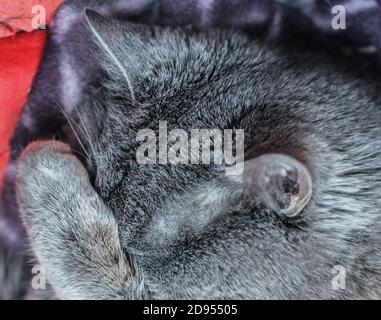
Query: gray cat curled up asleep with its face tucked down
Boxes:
[{"xmin": 17, "ymin": 11, "xmax": 381, "ymax": 299}]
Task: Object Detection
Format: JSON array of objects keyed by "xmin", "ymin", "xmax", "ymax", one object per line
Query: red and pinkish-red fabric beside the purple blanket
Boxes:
[{"xmin": 0, "ymin": 0, "xmax": 62, "ymax": 188}]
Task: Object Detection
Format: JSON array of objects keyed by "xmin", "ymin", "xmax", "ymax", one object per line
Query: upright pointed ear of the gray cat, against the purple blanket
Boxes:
[{"xmin": 83, "ymin": 9, "xmax": 151, "ymax": 100}]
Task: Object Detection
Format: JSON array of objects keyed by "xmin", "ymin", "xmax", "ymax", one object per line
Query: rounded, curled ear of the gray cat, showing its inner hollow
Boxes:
[{"xmin": 229, "ymin": 153, "xmax": 313, "ymax": 217}]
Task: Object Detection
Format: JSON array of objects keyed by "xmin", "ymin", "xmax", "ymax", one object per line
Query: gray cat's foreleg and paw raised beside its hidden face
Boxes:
[{"xmin": 17, "ymin": 142, "xmax": 139, "ymax": 299}]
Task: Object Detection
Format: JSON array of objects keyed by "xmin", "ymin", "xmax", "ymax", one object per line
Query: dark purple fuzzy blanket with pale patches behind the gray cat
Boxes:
[{"xmin": 0, "ymin": 0, "xmax": 381, "ymax": 297}]
